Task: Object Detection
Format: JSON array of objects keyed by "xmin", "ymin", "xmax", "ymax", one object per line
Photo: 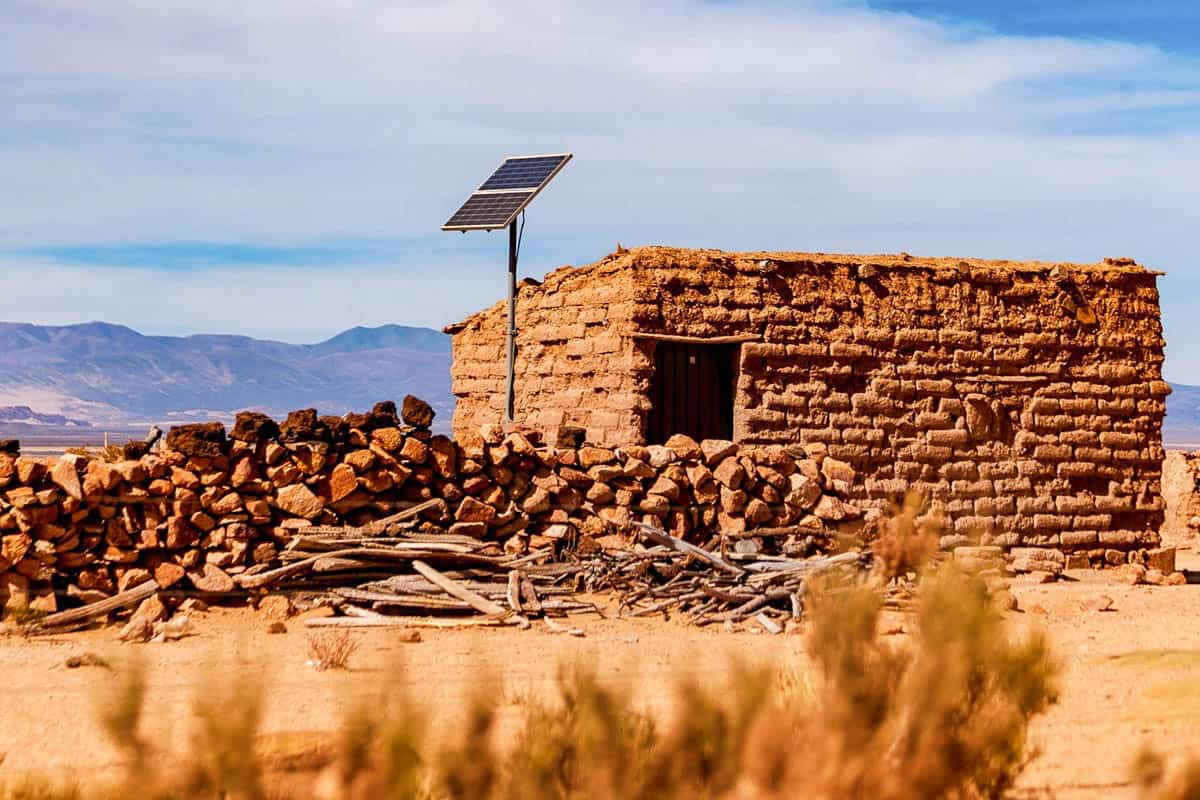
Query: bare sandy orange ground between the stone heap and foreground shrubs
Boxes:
[{"xmin": 7, "ymin": 552, "xmax": 1200, "ymax": 798}]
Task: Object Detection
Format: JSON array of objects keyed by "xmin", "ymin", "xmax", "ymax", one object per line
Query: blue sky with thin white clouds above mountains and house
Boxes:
[{"xmin": 7, "ymin": 0, "xmax": 1200, "ymax": 384}]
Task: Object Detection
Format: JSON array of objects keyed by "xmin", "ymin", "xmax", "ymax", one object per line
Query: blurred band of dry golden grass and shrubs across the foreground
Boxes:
[{"xmin": 0, "ymin": 556, "xmax": 1051, "ymax": 800}]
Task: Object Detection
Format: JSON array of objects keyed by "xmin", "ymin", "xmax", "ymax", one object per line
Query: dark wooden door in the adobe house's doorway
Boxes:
[{"xmin": 646, "ymin": 342, "xmax": 738, "ymax": 444}]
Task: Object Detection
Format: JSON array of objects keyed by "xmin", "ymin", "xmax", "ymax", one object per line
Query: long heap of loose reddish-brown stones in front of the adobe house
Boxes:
[{"xmin": 0, "ymin": 397, "xmax": 865, "ymax": 612}]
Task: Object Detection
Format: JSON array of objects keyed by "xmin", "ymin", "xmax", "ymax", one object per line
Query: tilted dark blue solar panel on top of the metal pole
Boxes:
[{"xmin": 442, "ymin": 152, "xmax": 571, "ymax": 230}]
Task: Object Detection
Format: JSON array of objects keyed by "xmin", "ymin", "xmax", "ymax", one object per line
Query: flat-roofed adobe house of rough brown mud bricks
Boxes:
[{"xmin": 446, "ymin": 247, "xmax": 1170, "ymax": 560}]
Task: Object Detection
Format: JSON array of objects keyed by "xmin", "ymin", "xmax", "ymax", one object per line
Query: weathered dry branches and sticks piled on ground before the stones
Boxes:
[{"xmin": 32, "ymin": 500, "xmax": 865, "ymax": 636}]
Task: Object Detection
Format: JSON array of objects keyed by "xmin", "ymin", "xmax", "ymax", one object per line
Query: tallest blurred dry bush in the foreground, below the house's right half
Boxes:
[{"xmin": 797, "ymin": 566, "xmax": 1057, "ymax": 799}]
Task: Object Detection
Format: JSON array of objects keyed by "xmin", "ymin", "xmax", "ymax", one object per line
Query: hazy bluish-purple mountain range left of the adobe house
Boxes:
[{"xmin": 0, "ymin": 323, "xmax": 454, "ymax": 429}]
